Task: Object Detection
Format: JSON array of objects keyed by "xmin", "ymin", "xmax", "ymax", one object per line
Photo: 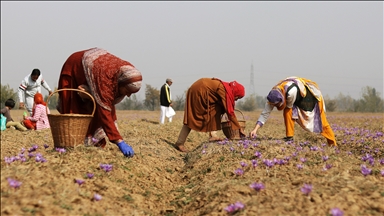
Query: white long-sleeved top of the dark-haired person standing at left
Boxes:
[{"xmin": 18, "ymin": 74, "xmax": 51, "ymax": 103}]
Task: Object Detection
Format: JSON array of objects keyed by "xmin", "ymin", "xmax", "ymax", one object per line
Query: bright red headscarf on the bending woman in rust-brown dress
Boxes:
[{"xmin": 220, "ymin": 80, "xmax": 245, "ymax": 116}]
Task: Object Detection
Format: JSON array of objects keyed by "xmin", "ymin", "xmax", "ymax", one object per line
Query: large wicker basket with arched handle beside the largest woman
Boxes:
[{"xmin": 47, "ymin": 89, "xmax": 96, "ymax": 148}]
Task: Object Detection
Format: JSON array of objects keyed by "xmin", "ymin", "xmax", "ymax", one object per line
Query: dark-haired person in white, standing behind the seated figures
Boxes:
[{"xmin": 18, "ymin": 68, "xmax": 52, "ymax": 115}]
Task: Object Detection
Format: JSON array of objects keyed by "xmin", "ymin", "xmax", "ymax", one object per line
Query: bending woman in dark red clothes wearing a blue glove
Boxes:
[{"xmin": 57, "ymin": 48, "xmax": 142, "ymax": 157}]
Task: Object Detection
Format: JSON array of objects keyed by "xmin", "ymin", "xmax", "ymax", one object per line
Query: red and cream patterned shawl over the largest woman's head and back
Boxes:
[{"xmin": 83, "ymin": 48, "xmax": 142, "ymax": 111}]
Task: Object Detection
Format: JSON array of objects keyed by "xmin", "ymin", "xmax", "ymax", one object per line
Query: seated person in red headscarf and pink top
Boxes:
[{"xmin": 23, "ymin": 93, "xmax": 50, "ymax": 130}]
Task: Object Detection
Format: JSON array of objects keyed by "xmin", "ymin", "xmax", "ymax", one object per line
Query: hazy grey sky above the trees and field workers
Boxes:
[{"xmin": 1, "ymin": 1, "xmax": 384, "ymax": 99}]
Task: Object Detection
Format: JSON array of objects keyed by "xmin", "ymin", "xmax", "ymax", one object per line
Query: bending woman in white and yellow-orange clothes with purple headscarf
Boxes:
[{"xmin": 249, "ymin": 76, "xmax": 337, "ymax": 146}]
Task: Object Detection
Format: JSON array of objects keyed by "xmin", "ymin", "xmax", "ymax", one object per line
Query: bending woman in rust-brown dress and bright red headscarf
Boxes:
[{"xmin": 175, "ymin": 78, "xmax": 245, "ymax": 152}]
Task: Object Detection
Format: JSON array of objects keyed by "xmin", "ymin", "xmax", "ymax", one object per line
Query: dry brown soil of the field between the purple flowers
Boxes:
[{"xmin": 1, "ymin": 110, "xmax": 384, "ymax": 215}]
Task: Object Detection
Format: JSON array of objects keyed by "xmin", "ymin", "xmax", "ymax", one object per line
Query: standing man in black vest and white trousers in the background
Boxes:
[{"xmin": 160, "ymin": 78, "xmax": 173, "ymax": 124}]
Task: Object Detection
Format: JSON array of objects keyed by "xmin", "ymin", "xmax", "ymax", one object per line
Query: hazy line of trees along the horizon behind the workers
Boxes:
[{"xmin": 1, "ymin": 84, "xmax": 384, "ymax": 113}]
